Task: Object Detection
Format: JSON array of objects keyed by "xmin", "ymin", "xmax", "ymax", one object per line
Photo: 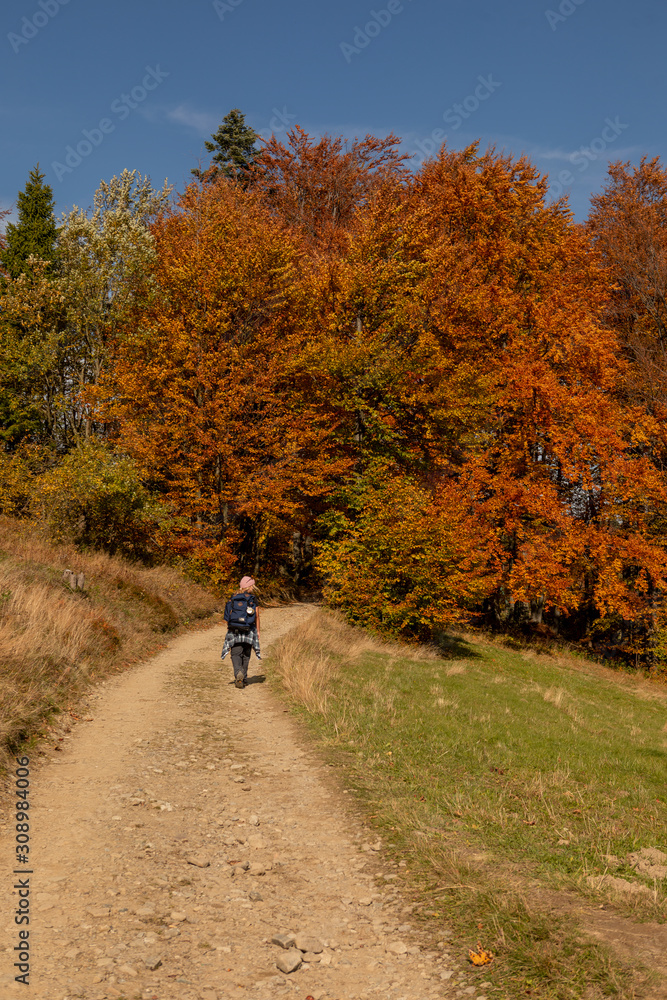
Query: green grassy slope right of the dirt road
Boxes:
[{"xmin": 269, "ymin": 613, "xmax": 667, "ymax": 1000}]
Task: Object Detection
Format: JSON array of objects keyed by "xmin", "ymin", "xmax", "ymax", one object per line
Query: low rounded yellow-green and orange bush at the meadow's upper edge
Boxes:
[{"xmin": 316, "ymin": 466, "xmax": 494, "ymax": 640}]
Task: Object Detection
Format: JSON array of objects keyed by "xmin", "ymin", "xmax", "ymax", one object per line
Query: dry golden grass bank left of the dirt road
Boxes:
[{"xmin": 0, "ymin": 518, "xmax": 217, "ymax": 777}]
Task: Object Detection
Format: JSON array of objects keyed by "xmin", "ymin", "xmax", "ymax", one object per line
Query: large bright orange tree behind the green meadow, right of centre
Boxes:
[{"xmin": 314, "ymin": 147, "xmax": 664, "ymax": 631}]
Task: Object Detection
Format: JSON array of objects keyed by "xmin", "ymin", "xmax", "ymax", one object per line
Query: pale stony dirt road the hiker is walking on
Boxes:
[{"xmin": 0, "ymin": 607, "xmax": 468, "ymax": 1000}]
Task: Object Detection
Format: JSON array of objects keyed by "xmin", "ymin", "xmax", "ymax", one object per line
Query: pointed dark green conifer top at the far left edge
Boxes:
[{"xmin": 0, "ymin": 164, "xmax": 57, "ymax": 278}]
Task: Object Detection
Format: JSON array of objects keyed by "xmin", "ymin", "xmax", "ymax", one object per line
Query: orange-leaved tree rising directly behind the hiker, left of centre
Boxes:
[{"xmin": 103, "ymin": 182, "xmax": 350, "ymax": 579}]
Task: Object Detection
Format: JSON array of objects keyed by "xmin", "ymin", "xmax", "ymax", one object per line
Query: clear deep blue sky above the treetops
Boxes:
[{"xmin": 0, "ymin": 0, "xmax": 667, "ymax": 219}]
